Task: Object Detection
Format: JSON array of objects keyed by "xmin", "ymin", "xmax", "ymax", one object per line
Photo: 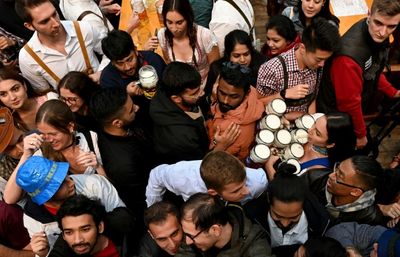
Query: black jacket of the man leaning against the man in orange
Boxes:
[{"xmin": 150, "ymin": 89, "xmax": 209, "ymax": 164}]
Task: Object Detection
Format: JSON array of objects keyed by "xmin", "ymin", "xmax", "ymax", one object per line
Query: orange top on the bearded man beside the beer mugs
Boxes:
[{"xmin": 207, "ymin": 87, "xmax": 265, "ymax": 161}]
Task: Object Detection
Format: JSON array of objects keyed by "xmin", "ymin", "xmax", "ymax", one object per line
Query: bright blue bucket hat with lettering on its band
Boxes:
[{"xmin": 16, "ymin": 156, "xmax": 69, "ymax": 205}]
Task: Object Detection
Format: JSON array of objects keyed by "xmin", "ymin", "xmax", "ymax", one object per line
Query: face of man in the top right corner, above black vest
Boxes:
[{"xmin": 368, "ymin": 12, "xmax": 400, "ymax": 43}]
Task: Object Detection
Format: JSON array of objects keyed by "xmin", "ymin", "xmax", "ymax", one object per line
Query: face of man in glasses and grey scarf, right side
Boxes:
[{"xmin": 326, "ymin": 159, "xmax": 363, "ymax": 196}]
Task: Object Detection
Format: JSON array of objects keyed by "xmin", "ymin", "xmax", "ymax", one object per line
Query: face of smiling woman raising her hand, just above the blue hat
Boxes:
[{"xmin": 37, "ymin": 122, "xmax": 73, "ymax": 151}]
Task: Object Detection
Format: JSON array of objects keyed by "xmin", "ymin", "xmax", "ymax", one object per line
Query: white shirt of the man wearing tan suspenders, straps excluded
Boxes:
[{"xmin": 19, "ymin": 21, "xmax": 110, "ymax": 91}]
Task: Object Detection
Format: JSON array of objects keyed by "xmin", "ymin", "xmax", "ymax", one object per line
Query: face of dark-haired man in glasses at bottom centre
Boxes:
[{"xmin": 181, "ymin": 215, "xmax": 217, "ymax": 252}]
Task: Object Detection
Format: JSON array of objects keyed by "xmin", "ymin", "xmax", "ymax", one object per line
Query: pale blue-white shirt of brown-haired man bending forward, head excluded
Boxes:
[{"xmin": 146, "ymin": 160, "xmax": 268, "ymax": 206}]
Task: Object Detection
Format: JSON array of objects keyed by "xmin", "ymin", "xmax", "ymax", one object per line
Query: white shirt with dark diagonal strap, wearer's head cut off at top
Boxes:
[{"xmin": 209, "ymin": 0, "xmax": 256, "ymax": 56}]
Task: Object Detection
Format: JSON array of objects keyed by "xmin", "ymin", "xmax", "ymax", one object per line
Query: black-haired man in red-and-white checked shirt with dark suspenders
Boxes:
[{"xmin": 257, "ymin": 18, "xmax": 340, "ymax": 121}]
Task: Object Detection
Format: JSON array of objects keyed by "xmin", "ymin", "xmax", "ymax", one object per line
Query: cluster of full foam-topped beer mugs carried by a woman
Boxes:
[{"xmin": 249, "ymin": 99, "xmax": 315, "ymax": 171}]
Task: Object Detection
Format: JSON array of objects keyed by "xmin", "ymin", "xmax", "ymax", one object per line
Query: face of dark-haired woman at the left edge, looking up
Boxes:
[{"xmin": 0, "ymin": 79, "xmax": 28, "ymax": 110}]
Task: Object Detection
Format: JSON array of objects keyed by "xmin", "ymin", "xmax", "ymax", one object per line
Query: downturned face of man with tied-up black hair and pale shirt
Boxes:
[{"xmin": 269, "ymin": 198, "xmax": 303, "ymax": 231}]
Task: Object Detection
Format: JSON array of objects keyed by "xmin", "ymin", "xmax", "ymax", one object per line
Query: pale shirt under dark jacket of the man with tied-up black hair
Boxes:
[{"xmin": 268, "ymin": 211, "xmax": 308, "ymax": 247}]
